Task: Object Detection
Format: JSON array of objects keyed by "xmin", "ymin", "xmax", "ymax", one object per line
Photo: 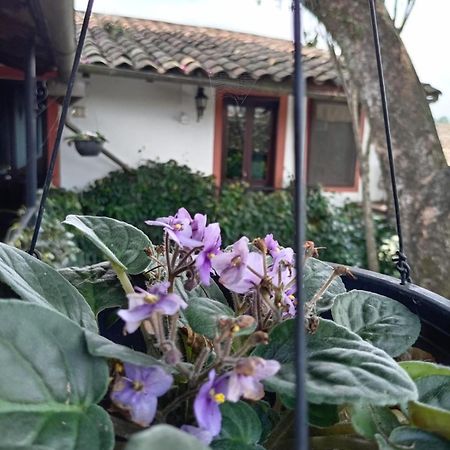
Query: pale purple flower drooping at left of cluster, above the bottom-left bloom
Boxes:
[{"xmin": 117, "ymin": 282, "xmax": 187, "ymax": 333}]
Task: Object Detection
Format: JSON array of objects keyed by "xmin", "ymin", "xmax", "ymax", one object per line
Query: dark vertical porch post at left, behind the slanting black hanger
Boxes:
[{"xmin": 25, "ymin": 39, "xmax": 37, "ymax": 208}]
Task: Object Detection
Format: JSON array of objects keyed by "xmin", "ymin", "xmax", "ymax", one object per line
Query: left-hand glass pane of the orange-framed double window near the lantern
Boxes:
[{"xmin": 225, "ymin": 105, "xmax": 246, "ymax": 179}]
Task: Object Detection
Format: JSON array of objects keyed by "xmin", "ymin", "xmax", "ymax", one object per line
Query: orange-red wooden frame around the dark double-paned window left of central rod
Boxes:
[{"xmin": 213, "ymin": 89, "xmax": 288, "ymax": 189}]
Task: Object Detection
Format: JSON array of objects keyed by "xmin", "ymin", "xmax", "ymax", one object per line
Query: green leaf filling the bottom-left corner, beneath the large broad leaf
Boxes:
[{"xmin": 0, "ymin": 405, "xmax": 114, "ymax": 450}]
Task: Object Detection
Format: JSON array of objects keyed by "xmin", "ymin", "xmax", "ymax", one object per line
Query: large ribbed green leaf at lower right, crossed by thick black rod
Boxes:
[{"xmin": 254, "ymin": 319, "xmax": 417, "ymax": 406}]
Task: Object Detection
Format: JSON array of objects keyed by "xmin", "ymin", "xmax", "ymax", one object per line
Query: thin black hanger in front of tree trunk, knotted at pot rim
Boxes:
[{"xmin": 369, "ymin": 0, "xmax": 411, "ymax": 284}]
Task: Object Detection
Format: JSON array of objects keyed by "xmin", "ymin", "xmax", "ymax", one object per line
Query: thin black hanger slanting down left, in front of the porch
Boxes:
[{"xmin": 28, "ymin": 0, "xmax": 94, "ymax": 255}]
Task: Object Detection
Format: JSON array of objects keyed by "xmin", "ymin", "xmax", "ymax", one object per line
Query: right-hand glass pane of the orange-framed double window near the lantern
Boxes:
[{"xmin": 251, "ymin": 107, "xmax": 273, "ymax": 181}]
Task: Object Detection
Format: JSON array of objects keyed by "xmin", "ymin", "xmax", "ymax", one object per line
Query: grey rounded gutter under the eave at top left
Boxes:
[{"xmin": 37, "ymin": 0, "xmax": 76, "ymax": 81}]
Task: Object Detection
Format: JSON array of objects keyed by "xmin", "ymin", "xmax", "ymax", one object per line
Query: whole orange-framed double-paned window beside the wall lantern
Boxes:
[{"xmin": 214, "ymin": 92, "xmax": 287, "ymax": 189}]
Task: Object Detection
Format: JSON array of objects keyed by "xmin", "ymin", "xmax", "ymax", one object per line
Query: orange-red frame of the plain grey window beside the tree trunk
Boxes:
[{"xmin": 305, "ymin": 96, "xmax": 365, "ymax": 193}]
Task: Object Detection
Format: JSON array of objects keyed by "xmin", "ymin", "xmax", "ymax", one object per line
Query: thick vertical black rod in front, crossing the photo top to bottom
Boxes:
[{"xmin": 293, "ymin": 0, "xmax": 309, "ymax": 450}]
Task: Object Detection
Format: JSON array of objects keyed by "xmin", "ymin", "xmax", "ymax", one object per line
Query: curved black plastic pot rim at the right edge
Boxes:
[{"xmin": 343, "ymin": 268, "xmax": 450, "ymax": 365}]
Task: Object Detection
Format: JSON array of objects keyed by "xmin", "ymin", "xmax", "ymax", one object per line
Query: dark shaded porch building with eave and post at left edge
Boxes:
[{"xmin": 0, "ymin": 0, "xmax": 75, "ymax": 238}]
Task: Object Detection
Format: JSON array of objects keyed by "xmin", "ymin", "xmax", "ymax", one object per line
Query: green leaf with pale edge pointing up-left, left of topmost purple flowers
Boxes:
[{"xmin": 63, "ymin": 215, "xmax": 152, "ymax": 275}]
